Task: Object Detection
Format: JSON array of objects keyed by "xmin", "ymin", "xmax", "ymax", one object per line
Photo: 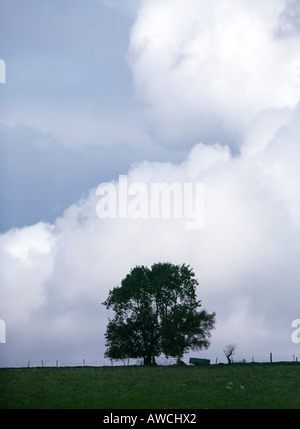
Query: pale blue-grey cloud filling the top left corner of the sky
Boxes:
[{"xmin": 0, "ymin": 0, "xmax": 140, "ymax": 145}]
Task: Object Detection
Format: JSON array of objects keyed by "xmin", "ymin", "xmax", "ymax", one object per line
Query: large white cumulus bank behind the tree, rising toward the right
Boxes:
[{"xmin": 0, "ymin": 103, "xmax": 300, "ymax": 362}]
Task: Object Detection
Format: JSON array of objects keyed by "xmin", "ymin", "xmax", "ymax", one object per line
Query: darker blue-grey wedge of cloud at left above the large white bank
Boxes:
[{"xmin": 0, "ymin": 124, "xmax": 186, "ymax": 231}]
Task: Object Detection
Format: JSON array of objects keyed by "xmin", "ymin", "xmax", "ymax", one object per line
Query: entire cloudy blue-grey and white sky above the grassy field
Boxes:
[{"xmin": 0, "ymin": 0, "xmax": 300, "ymax": 366}]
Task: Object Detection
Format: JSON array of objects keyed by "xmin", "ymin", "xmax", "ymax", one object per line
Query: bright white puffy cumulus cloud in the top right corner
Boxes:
[{"xmin": 129, "ymin": 0, "xmax": 300, "ymax": 143}]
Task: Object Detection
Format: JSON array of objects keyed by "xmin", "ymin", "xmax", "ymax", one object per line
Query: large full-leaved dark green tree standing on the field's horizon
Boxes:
[{"xmin": 103, "ymin": 263, "xmax": 215, "ymax": 364}]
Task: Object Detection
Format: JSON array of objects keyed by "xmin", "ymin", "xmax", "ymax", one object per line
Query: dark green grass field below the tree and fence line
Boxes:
[{"xmin": 0, "ymin": 363, "xmax": 300, "ymax": 409}]
